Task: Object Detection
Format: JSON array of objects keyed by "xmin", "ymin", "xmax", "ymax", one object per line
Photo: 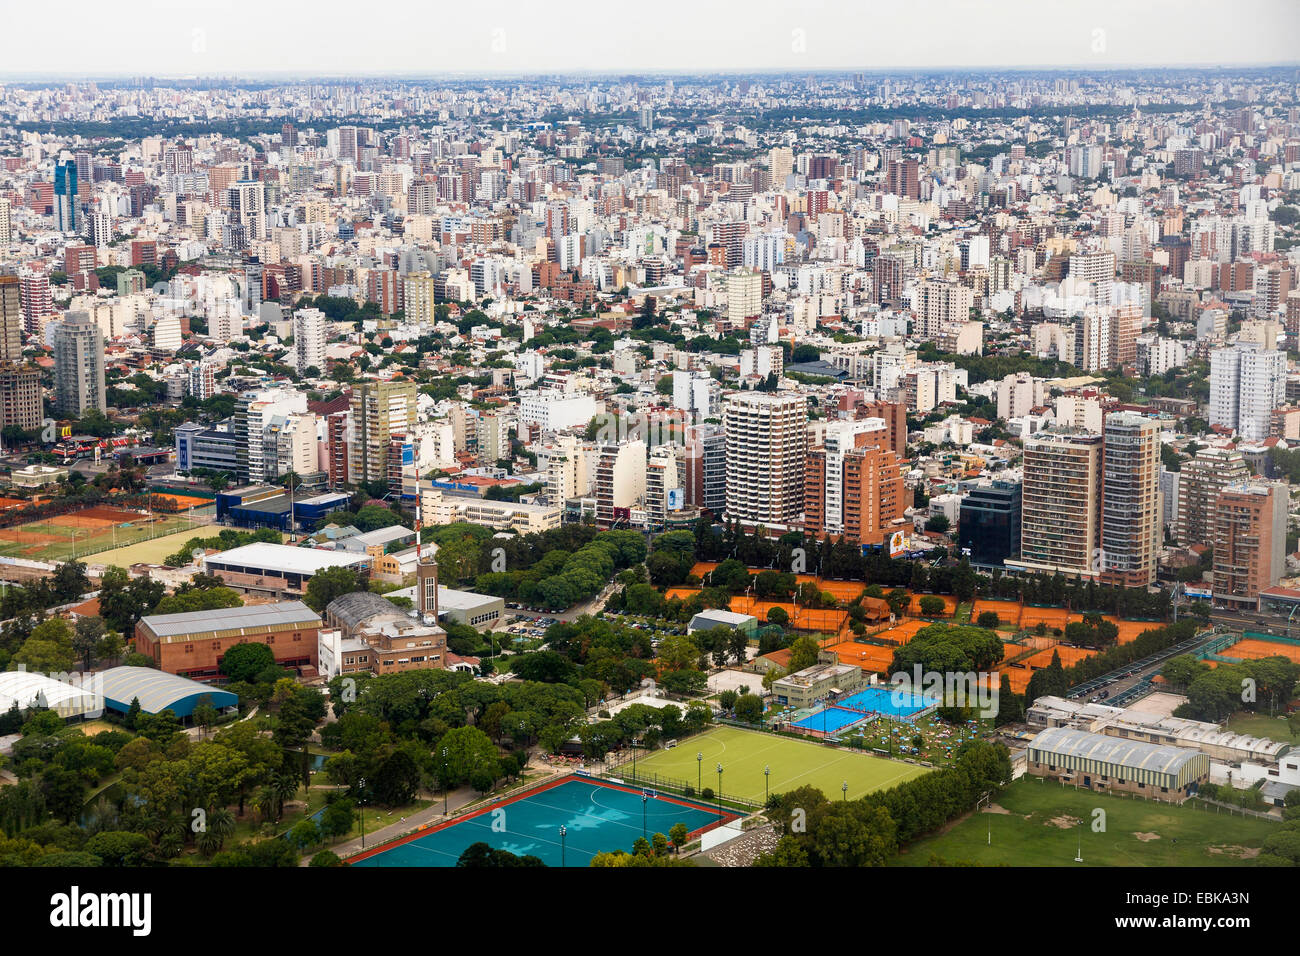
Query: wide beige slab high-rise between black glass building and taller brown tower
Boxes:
[{"xmin": 1008, "ymin": 432, "xmax": 1102, "ymax": 576}]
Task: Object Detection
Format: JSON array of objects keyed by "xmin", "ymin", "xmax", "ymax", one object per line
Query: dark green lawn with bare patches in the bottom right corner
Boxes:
[{"xmin": 894, "ymin": 777, "xmax": 1278, "ymax": 866}]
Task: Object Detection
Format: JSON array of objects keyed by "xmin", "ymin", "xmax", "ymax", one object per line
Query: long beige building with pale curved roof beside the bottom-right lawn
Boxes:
[{"xmin": 1027, "ymin": 727, "xmax": 1210, "ymax": 804}]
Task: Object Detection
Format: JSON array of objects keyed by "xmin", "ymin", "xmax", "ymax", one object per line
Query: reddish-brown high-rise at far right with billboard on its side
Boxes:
[{"xmin": 1213, "ymin": 483, "xmax": 1291, "ymax": 607}]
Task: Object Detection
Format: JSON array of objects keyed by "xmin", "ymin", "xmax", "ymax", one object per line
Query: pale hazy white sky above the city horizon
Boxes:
[{"xmin": 0, "ymin": 0, "xmax": 1300, "ymax": 77}]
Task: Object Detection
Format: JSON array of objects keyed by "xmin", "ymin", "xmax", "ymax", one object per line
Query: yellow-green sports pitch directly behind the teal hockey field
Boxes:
[{"xmin": 626, "ymin": 727, "xmax": 927, "ymax": 803}]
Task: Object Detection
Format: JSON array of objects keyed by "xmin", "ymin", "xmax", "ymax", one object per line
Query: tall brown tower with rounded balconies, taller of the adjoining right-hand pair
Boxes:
[{"xmin": 1101, "ymin": 412, "xmax": 1161, "ymax": 588}]
